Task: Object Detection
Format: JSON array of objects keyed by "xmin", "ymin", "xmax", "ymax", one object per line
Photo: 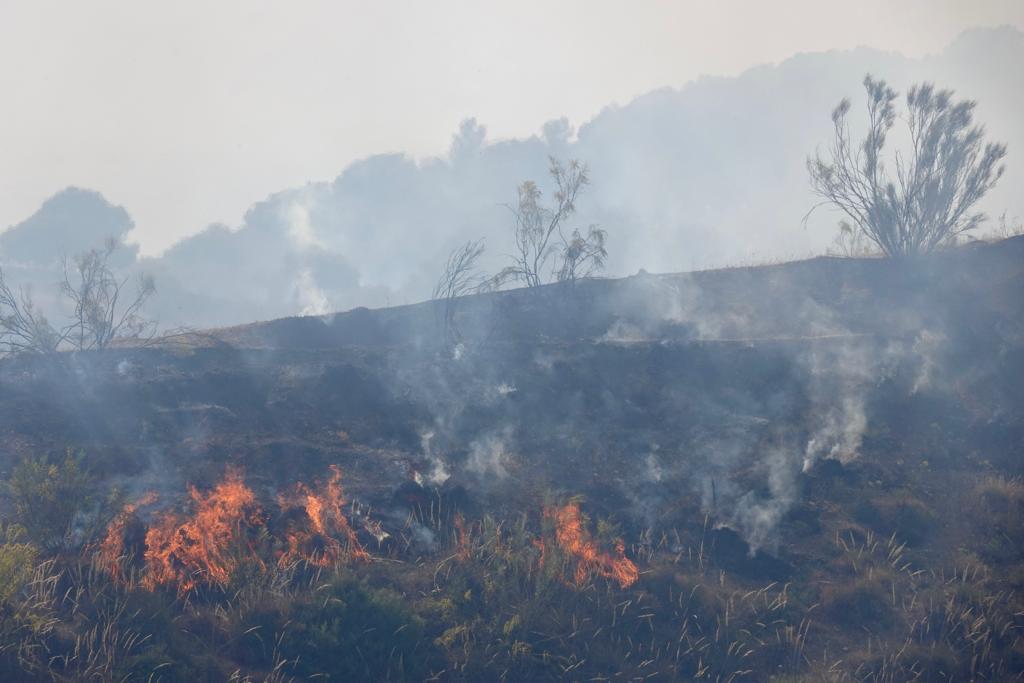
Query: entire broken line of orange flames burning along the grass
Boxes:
[{"xmin": 96, "ymin": 465, "xmax": 639, "ymax": 595}]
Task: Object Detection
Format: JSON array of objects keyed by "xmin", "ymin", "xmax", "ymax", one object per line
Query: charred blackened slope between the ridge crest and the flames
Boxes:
[{"xmin": 0, "ymin": 239, "xmax": 1024, "ymax": 680}]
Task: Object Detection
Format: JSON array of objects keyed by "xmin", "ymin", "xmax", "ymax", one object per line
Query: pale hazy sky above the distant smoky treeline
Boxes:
[{"xmin": 0, "ymin": 0, "xmax": 1024, "ymax": 254}]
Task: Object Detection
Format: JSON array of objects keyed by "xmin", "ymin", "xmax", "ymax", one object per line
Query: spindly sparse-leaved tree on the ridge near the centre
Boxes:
[{"xmin": 495, "ymin": 158, "xmax": 605, "ymax": 287}]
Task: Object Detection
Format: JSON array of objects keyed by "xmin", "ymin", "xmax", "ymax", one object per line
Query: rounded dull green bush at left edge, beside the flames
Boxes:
[{"xmin": 7, "ymin": 451, "xmax": 94, "ymax": 550}]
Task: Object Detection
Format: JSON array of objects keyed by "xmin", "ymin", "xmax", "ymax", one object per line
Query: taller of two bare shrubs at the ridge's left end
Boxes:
[{"xmin": 60, "ymin": 240, "xmax": 157, "ymax": 350}]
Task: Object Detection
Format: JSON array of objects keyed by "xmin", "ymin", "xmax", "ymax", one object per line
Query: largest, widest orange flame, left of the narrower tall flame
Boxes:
[{"xmin": 142, "ymin": 467, "xmax": 262, "ymax": 594}]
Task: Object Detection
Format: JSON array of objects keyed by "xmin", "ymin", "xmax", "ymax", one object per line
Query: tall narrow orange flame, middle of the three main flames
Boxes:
[{"xmin": 279, "ymin": 465, "xmax": 370, "ymax": 567}]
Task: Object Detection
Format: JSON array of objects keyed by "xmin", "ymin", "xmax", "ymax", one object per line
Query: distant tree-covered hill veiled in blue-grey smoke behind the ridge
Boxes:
[{"xmin": 0, "ymin": 28, "xmax": 1024, "ymax": 327}]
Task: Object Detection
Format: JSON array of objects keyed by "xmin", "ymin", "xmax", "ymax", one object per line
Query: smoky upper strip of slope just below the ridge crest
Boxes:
[{"xmin": 217, "ymin": 237, "xmax": 1024, "ymax": 349}]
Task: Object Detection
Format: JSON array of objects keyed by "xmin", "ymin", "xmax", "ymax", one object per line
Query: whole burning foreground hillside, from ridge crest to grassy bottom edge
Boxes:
[{"xmin": 0, "ymin": 238, "xmax": 1024, "ymax": 681}]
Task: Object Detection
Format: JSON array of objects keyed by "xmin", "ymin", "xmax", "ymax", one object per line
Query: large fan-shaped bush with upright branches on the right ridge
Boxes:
[{"xmin": 807, "ymin": 75, "xmax": 1007, "ymax": 256}]
